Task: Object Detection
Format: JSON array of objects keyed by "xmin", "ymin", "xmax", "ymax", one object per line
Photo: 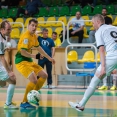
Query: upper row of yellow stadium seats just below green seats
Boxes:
[{"xmin": 0, "ymin": 15, "xmax": 117, "ymax": 28}]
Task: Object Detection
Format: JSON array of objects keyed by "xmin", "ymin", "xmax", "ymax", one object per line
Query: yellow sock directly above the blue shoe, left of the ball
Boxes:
[{"xmin": 23, "ymin": 82, "xmax": 35, "ymax": 102}]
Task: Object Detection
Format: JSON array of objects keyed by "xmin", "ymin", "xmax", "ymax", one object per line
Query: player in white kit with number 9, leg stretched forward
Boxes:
[{"xmin": 69, "ymin": 14, "xmax": 117, "ymax": 111}]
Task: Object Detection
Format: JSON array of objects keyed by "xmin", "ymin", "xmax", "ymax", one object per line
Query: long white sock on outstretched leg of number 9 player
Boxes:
[{"xmin": 79, "ymin": 75, "xmax": 101, "ymax": 106}]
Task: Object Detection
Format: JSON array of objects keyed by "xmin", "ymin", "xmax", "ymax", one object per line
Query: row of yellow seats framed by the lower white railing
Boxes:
[{"xmin": 67, "ymin": 50, "xmax": 100, "ymax": 64}]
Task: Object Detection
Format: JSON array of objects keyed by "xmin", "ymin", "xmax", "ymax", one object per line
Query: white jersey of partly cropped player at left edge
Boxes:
[{"xmin": 0, "ymin": 33, "xmax": 7, "ymax": 55}]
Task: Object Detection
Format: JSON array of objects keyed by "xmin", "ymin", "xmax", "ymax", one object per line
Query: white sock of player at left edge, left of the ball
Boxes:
[{"xmin": 6, "ymin": 84, "xmax": 15, "ymax": 105}]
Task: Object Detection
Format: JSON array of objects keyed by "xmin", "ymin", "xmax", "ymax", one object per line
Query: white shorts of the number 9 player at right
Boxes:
[{"xmin": 97, "ymin": 57, "xmax": 117, "ymax": 76}]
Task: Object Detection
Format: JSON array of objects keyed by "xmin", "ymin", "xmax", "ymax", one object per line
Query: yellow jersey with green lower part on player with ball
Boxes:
[{"xmin": 15, "ymin": 31, "xmax": 39, "ymax": 64}]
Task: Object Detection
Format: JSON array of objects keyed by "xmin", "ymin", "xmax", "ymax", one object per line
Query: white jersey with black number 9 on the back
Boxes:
[{"xmin": 95, "ymin": 24, "xmax": 117, "ymax": 56}]
